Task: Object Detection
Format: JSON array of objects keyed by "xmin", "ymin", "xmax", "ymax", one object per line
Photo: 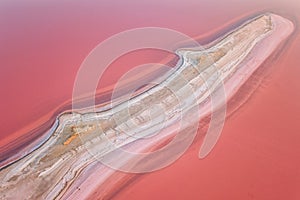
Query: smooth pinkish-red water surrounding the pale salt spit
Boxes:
[{"xmin": 0, "ymin": 0, "xmax": 300, "ymax": 199}]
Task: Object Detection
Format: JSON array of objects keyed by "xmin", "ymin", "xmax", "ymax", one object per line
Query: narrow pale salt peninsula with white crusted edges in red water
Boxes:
[{"xmin": 0, "ymin": 14, "xmax": 294, "ymax": 199}]
